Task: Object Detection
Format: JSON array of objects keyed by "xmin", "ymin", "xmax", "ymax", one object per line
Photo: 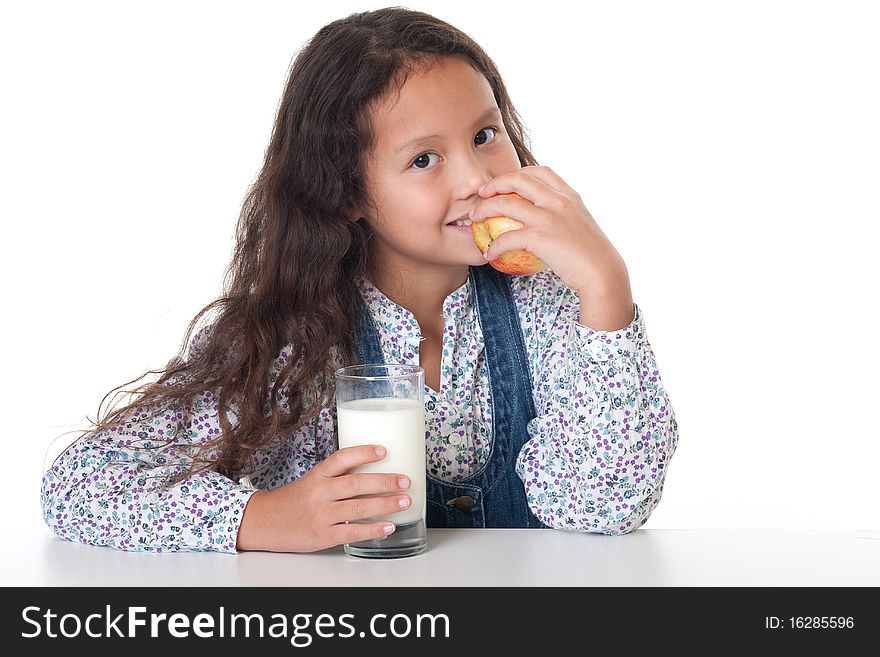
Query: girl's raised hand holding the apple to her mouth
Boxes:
[{"xmin": 471, "ymin": 166, "xmax": 628, "ymax": 292}]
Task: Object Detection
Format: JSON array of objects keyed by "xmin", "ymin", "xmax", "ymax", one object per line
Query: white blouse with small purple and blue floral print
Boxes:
[{"xmin": 41, "ymin": 269, "xmax": 678, "ymax": 553}]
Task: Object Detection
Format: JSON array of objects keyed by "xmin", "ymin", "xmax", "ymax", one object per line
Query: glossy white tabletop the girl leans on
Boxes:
[{"xmin": 8, "ymin": 529, "xmax": 880, "ymax": 586}]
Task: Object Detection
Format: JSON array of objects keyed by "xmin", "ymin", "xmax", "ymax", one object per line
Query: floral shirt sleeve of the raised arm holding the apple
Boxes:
[{"xmin": 513, "ymin": 270, "xmax": 678, "ymax": 535}]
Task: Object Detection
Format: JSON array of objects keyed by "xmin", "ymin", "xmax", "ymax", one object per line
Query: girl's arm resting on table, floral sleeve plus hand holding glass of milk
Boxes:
[{"xmin": 41, "ymin": 337, "xmax": 420, "ymax": 553}]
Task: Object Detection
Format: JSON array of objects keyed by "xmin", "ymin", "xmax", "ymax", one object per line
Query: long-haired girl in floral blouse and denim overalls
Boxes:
[{"xmin": 42, "ymin": 8, "xmax": 678, "ymax": 553}]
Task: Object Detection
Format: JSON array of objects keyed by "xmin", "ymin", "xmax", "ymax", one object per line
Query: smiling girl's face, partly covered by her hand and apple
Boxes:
[{"xmin": 360, "ymin": 57, "xmax": 520, "ymax": 279}]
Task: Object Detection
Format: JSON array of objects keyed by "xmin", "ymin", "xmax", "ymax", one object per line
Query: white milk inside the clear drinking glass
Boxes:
[{"xmin": 336, "ymin": 397, "xmax": 425, "ymax": 525}]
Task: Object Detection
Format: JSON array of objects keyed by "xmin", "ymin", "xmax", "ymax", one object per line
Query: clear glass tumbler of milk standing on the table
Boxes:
[{"xmin": 336, "ymin": 363, "xmax": 428, "ymax": 558}]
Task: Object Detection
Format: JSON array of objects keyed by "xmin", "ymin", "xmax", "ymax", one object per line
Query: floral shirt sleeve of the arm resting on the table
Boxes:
[{"xmin": 41, "ymin": 392, "xmax": 256, "ymax": 553}]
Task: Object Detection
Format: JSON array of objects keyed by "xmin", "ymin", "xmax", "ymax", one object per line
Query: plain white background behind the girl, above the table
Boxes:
[{"xmin": 0, "ymin": 0, "xmax": 880, "ymax": 542}]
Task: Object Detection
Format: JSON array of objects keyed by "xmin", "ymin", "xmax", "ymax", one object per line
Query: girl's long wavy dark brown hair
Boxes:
[{"xmin": 72, "ymin": 7, "xmax": 537, "ymax": 480}]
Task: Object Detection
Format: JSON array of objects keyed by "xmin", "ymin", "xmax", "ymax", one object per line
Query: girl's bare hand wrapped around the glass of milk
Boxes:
[{"xmin": 237, "ymin": 445, "xmax": 412, "ymax": 552}]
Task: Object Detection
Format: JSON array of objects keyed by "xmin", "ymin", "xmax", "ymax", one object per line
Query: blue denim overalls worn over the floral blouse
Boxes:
[{"xmin": 356, "ymin": 264, "xmax": 545, "ymax": 528}]
